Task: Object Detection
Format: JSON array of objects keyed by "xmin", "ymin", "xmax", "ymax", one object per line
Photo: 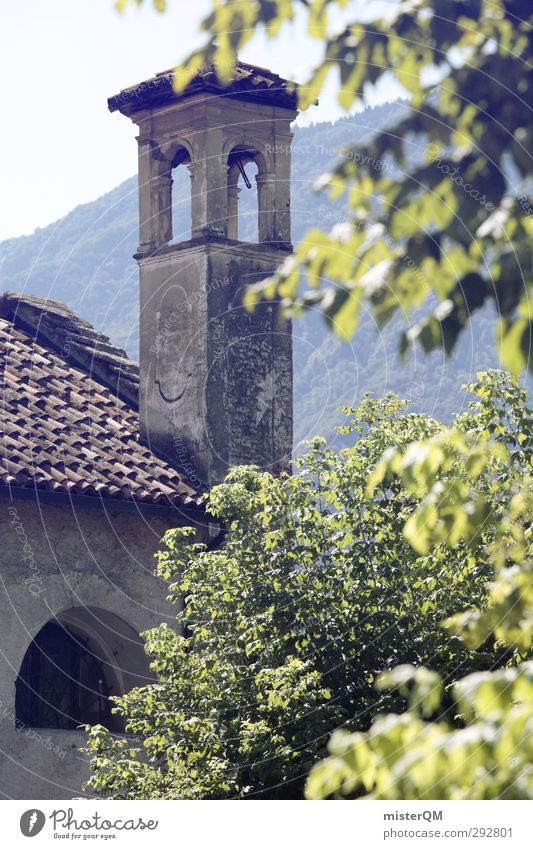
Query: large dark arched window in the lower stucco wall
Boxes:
[{"xmin": 15, "ymin": 608, "xmax": 153, "ymax": 731}]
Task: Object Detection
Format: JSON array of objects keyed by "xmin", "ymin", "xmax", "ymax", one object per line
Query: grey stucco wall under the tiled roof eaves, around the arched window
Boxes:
[{"xmin": 0, "ymin": 497, "xmax": 195, "ymax": 799}]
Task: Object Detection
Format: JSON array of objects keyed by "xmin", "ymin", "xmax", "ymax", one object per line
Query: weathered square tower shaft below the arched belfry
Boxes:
[{"xmin": 139, "ymin": 241, "xmax": 292, "ymax": 486}]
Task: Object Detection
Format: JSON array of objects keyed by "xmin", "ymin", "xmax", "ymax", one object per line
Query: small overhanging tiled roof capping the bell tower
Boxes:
[{"xmin": 107, "ymin": 61, "xmax": 297, "ymax": 115}]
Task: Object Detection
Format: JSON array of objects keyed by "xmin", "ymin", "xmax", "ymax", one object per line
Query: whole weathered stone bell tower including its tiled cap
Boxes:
[{"xmin": 108, "ymin": 62, "xmax": 297, "ymax": 486}]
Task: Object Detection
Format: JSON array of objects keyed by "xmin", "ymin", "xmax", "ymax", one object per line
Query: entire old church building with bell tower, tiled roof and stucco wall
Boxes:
[{"xmin": 0, "ymin": 63, "xmax": 297, "ymax": 799}]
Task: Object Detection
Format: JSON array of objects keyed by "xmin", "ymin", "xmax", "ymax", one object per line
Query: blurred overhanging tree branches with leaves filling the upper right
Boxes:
[{"xmin": 118, "ymin": 0, "xmax": 533, "ymax": 371}]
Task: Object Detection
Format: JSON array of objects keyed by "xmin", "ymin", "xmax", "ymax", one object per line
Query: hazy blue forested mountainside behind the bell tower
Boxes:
[{"xmin": 0, "ymin": 103, "xmax": 516, "ymax": 441}]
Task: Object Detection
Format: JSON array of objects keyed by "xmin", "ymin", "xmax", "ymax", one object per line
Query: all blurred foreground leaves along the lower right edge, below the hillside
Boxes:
[{"xmin": 306, "ymin": 373, "xmax": 533, "ymax": 799}]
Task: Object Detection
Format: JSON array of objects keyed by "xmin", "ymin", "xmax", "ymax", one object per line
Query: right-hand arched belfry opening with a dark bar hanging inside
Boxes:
[{"xmin": 228, "ymin": 147, "xmax": 260, "ymax": 242}]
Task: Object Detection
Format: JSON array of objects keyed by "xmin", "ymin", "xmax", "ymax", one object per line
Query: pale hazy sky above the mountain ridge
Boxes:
[{"xmin": 0, "ymin": 0, "xmax": 400, "ymax": 240}]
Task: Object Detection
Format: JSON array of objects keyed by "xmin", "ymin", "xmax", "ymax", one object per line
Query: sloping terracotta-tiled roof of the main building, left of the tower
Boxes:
[{"xmin": 0, "ymin": 293, "xmax": 202, "ymax": 508}]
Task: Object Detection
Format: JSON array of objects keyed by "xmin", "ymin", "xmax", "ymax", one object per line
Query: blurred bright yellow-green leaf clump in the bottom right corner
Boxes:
[{"xmin": 306, "ymin": 661, "xmax": 533, "ymax": 799}]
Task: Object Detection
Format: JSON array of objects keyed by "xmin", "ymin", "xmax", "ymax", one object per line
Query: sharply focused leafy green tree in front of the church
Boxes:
[{"xmin": 84, "ymin": 374, "xmax": 530, "ymax": 798}]
